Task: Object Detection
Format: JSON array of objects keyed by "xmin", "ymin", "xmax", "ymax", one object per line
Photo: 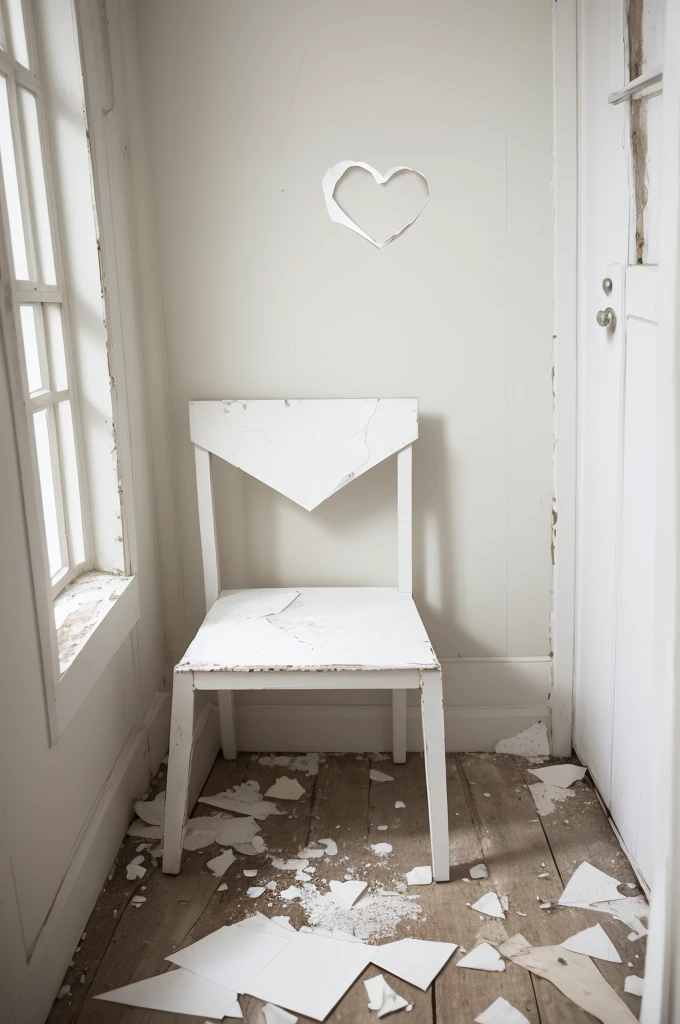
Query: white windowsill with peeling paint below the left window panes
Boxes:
[{"xmin": 54, "ymin": 571, "xmax": 139, "ymax": 735}]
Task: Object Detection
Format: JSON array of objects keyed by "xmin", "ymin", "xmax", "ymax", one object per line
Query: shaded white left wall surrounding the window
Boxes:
[{"xmin": 0, "ymin": 0, "xmax": 167, "ymax": 1024}]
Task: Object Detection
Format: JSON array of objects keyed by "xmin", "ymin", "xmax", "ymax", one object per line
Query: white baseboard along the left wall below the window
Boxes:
[{"xmin": 8, "ymin": 692, "xmax": 215, "ymax": 1024}]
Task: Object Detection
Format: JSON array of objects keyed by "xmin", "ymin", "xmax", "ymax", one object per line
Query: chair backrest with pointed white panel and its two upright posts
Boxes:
[{"xmin": 189, "ymin": 398, "xmax": 418, "ymax": 607}]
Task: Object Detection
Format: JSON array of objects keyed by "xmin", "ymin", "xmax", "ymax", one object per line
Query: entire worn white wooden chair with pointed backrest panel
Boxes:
[{"xmin": 163, "ymin": 398, "xmax": 449, "ymax": 882}]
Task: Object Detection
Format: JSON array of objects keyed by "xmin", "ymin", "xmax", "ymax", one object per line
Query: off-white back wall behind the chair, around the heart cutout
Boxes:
[{"xmin": 139, "ymin": 0, "xmax": 553, "ymax": 744}]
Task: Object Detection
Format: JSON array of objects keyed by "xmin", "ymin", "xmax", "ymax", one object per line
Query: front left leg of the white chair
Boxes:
[{"xmin": 163, "ymin": 672, "xmax": 194, "ymax": 874}]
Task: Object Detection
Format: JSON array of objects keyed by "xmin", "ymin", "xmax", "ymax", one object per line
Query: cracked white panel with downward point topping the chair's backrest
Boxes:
[{"xmin": 189, "ymin": 398, "xmax": 418, "ymax": 511}]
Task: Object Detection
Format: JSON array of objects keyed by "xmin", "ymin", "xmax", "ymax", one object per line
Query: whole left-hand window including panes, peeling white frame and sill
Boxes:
[{"xmin": 0, "ymin": 0, "xmax": 139, "ymax": 742}]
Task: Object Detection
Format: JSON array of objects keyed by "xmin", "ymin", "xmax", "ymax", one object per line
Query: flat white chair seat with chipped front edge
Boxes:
[{"xmin": 175, "ymin": 587, "xmax": 439, "ymax": 672}]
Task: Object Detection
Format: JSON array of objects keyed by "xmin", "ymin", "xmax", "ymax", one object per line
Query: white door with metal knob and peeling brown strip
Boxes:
[{"xmin": 575, "ymin": 0, "xmax": 663, "ymax": 884}]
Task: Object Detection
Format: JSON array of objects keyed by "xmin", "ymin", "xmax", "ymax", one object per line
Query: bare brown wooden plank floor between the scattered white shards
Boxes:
[{"xmin": 48, "ymin": 754, "xmax": 644, "ymax": 1024}]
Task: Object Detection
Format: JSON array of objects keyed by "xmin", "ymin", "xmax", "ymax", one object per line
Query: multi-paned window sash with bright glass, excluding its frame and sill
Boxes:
[{"xmin": 0, "ymin": 0, "xmax": 91, "ymax": 596}]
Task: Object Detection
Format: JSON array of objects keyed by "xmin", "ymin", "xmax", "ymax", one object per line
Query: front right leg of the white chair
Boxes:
[{"xmin": 420, "ymin": 671, "xmax": 449, "ymax": 882}]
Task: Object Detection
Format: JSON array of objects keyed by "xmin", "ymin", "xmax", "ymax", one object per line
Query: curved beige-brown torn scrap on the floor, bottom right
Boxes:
[{"xmin": 510, "ymin": 946, "xmax": 637, "ymax": 1024}]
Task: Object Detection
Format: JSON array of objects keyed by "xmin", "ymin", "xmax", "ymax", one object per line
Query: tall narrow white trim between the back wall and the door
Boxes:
[{"xmin": 551, "ymin": 0, "xmax": 578, "ymax": 757}]
